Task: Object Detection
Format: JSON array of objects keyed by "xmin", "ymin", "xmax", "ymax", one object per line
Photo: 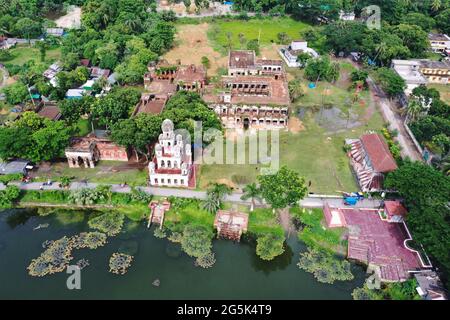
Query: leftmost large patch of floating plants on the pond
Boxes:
[{"xmin": 27, "ymin": 237, "xmax": 73, "ymax": 277}]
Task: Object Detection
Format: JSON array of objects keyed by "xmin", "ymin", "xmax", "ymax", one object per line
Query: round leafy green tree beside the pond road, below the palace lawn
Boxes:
[{"xmin": 258, "ymin": 166, "xmax": 307, "ymax": 209}]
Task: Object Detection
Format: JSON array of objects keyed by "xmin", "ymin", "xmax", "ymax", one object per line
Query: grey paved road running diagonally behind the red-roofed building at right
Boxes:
[{"xmin": 367, "ymin": 77, "xmax": 423, "ymax": 161}]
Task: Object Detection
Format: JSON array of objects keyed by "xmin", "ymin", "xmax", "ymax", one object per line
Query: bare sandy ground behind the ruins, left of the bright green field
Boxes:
[{"xmin": 164, "ymin": 23, "xmax": 228, "ymax": 76}]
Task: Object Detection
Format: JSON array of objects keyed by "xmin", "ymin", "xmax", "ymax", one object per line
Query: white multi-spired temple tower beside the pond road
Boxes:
[{"xmin": 148, "ymin": 119, "xmax": 195, "ymax": 187}]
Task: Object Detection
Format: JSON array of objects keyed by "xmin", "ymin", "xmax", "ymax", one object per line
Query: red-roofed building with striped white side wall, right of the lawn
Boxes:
[{"xmin": 346, "ymin": 133, "xmax": 397, "ymax": 192}]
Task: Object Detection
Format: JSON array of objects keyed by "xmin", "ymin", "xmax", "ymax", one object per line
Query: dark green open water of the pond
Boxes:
[{"xmin": 0, "ymin": 209, "xmax": 365, "ymax": 299}]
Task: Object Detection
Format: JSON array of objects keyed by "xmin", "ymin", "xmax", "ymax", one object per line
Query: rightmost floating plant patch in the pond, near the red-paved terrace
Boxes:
[{"xmin": 297, "ymin": 248, "xmax": 353, "ymax": 284}]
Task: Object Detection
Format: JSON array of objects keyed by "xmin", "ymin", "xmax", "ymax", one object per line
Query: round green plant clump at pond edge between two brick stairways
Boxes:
[{"xmin": 181, "ymin": 225, "xmax": 212, "ymax": 258}]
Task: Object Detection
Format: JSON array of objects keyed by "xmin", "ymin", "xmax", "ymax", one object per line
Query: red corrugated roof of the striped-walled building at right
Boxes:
[{"xmin": 361, "ymin": 133, "xmax": 397, "ymax": 172}]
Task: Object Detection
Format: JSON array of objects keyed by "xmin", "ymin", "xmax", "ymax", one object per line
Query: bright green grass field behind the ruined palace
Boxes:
[{"xmin": 208, "ymin": 17, "xmax": 309, "ymax": 49}]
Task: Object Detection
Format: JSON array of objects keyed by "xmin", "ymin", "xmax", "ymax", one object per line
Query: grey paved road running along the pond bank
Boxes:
[{"xmin": 0, "ymin": 182, "xmax": 381, "ymax": 208}]
